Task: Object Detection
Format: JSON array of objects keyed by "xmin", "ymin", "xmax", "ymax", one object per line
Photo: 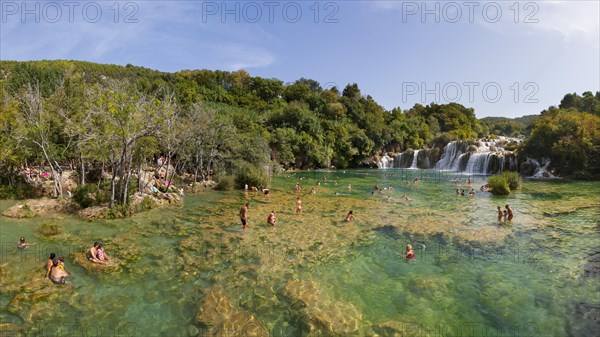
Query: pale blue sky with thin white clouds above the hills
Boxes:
[{"xmin": 0, "ymin": 0, "xmax": 600, "ymax": 117}]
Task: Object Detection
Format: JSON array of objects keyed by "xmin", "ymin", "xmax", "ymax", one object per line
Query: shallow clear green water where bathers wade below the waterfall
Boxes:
[{"xmin": 0, "ymin": 169, "xmax": 600, "ymax": 336}]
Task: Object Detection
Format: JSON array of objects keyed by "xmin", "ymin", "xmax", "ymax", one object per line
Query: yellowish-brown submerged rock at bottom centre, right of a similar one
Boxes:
[{"xmin": 282, "ymin": 280, "xmax": 361, "ymax": 334}]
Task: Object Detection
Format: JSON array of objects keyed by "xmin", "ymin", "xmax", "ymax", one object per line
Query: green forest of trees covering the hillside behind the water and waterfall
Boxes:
[{"xmin": 0, "ymin": 61, "xmax": 600, "ymax": 205}]
